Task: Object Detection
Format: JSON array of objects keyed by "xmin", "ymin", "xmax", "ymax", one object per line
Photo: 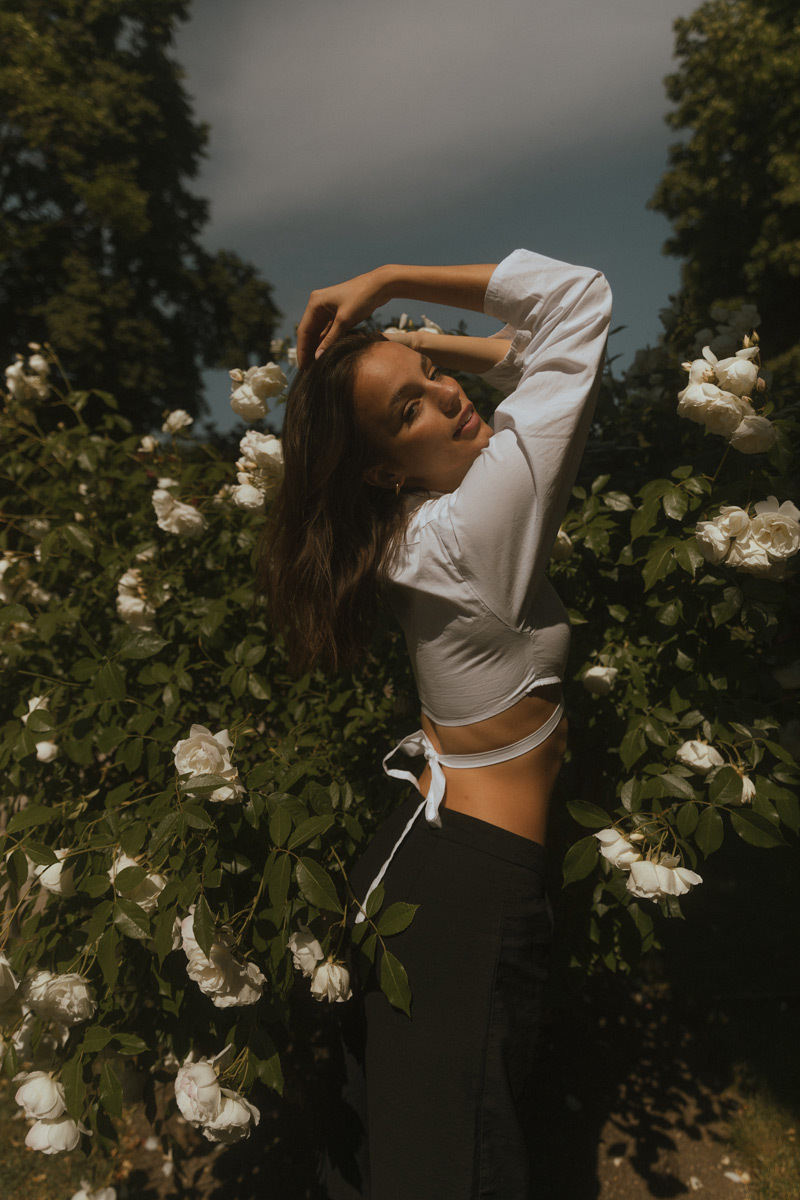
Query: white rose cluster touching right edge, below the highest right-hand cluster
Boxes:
[{"xmin": 694, "ymin": 496, "xmax": 800, "ymax": 580}]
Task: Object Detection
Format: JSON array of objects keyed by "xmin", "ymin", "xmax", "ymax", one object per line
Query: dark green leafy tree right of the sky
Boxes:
[{"xmin": 651, "ymin": 0, "xmax": 800, "ymax": 400}]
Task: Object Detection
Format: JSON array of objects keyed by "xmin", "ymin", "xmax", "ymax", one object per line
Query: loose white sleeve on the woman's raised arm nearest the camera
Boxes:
[{"xmin": 441, "ymin": 250, "xmax": 610, "ymax": 626}]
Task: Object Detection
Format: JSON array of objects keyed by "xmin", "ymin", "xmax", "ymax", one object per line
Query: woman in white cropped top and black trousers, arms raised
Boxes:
[{"xmin": 264, "ymin": 251, "xmax": 610, "ymax": 1200}]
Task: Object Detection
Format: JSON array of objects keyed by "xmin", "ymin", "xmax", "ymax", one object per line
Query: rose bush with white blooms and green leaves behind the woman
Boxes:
[{"xmin": 0, "ymin": 314, "xmax": 800, "ymax": 1153}]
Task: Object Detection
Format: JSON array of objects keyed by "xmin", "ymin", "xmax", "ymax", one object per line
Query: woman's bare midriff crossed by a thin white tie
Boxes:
[{"xmin": 420, "ymin": 684, "xmax": 567, "ymax": 845}]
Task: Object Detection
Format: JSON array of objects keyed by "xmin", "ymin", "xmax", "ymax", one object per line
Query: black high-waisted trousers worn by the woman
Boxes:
[{"xmin": 326, "ymin": 796, "xmax": 552, "ymax": 1200}]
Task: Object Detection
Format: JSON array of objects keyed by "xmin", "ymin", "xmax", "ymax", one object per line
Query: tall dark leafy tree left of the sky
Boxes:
[{"xmin": 0, "ymin": 0, "xmax": 278, "ymax": 428}]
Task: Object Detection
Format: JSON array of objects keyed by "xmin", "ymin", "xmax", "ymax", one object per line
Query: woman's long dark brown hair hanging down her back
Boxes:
[{"xmin": 255, "ymin": 330, "xmax": 405, "ymax": 672}]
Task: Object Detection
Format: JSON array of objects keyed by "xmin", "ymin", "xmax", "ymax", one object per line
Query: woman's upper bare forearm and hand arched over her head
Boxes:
[{"xmin": 297, "ymin": 263, "xmax": 494, "ymax": 367}]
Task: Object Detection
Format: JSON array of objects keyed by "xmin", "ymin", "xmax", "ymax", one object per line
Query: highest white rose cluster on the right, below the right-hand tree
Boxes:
[{"xmin": 678, "ymin": 350, "xmax": 777, "ymax": 454}]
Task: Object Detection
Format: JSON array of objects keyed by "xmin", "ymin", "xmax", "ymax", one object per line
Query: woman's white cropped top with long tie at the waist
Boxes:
[{"xmin": 356, "ymin": 250, "xmax": 610, "ymax": 923}]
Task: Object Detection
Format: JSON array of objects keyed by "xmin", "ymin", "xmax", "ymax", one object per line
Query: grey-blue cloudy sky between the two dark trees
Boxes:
[{"xmin": 176, "ymin": 0, "xmax": 694, "ymax": 427}]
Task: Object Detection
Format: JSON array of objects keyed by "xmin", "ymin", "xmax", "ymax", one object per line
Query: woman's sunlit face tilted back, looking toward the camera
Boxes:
[{"xmin": 354, "ymin": 342, "xmax": 492, "ymax": 492}]
